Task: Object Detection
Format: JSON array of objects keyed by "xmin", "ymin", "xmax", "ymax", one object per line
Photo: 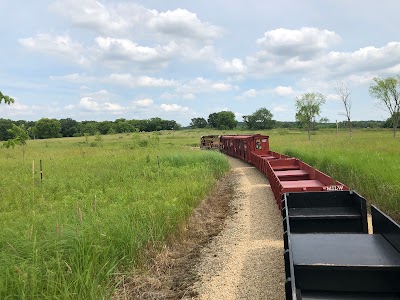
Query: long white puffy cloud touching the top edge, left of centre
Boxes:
[{"xmin": 50, "ymin": 0, "xmax": 222, "ymax": 41}]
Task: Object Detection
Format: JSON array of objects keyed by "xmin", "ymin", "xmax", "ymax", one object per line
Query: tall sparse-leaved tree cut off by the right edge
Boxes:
[{"xmin": 369, "ymin": 75, "xmax": 400, "ymax": 138}]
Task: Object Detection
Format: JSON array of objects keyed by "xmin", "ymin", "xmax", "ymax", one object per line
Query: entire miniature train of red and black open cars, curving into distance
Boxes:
[{"xmin": 201, "ymin": 134, "xmax": 400, "ymax": 300}]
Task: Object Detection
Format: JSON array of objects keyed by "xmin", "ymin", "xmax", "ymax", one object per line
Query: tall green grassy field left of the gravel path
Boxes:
[{"xmin": 0, "ymin": 132, "xmax": 229, "ymax": 299}]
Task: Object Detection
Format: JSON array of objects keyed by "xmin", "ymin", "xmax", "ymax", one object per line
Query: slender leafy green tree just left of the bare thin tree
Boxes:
[{"xmin": 296, "ymin": 93, "xmax": 325, "ymax": 140}]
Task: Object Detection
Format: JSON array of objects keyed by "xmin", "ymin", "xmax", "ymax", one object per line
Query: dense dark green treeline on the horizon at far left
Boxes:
[{"xmin": 0, "ymin": 118, "xmax": 181, "ymax": 141}]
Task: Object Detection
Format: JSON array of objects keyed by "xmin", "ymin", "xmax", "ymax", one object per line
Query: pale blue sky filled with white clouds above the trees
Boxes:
[{"xmin": 0, "ymin": 0, "xmax": 400, "ymax": 126}]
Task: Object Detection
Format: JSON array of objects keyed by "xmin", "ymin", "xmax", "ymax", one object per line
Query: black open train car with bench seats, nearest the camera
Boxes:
[{"xmin": 282, "ymin": 191, "xmax": 400, "ymax": 300}]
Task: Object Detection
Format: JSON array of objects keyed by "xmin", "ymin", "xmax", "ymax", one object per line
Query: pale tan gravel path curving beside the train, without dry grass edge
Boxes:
[{"xmin": 193, "ymin": 157, "xmax": 285, "ymax": 300}]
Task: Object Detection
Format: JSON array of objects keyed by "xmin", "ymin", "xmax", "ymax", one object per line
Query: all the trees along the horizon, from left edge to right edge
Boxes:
[{"xmin": 0, "ymin": 75, "xmax": 400, "ymax": 140}]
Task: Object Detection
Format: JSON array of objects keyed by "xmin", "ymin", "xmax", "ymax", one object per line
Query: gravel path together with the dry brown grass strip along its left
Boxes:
[{"xmin": 117, "ymin": 157, "xmax": 285, "ymax": 300}]
